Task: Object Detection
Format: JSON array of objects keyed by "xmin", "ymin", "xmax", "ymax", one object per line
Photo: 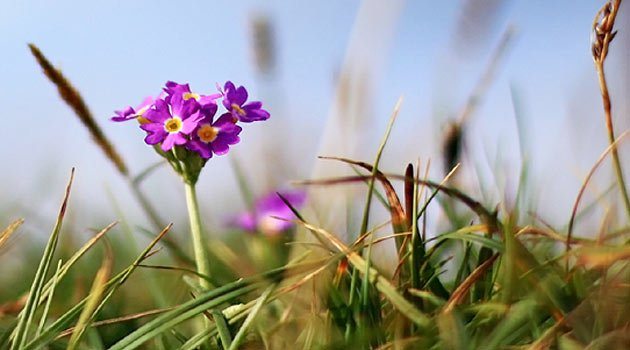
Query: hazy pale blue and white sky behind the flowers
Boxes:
[{"xmin": 0, "ymin": 0, "xmax": 630, "ymax": 238}]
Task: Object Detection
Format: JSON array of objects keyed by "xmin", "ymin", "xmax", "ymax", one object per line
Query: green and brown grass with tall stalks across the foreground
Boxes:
[{"xmin": 0, "ymin": 1, "xmax": 630, "ymax": 350}]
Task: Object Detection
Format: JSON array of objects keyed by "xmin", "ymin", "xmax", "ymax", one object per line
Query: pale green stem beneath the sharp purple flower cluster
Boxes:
[{"xmin": 184, "ymin": 181, "xmax": 211, "ymax": 289}]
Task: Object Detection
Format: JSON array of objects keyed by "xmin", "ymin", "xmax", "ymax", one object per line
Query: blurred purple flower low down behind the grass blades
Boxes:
[{"xmin": 231, "ymin": 191, "xmax": 306, "ymax": 236}]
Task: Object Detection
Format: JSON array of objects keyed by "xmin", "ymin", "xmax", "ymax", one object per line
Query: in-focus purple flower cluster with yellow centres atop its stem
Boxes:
[{"xmin": 111, "ymin": 81, "xmax": 270, "ymax": 159}]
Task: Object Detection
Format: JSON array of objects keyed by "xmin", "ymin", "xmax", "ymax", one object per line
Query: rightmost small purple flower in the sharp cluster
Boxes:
[{"xmin": 223, "ymin": 81, "xmax": 270, "ymax": 123}]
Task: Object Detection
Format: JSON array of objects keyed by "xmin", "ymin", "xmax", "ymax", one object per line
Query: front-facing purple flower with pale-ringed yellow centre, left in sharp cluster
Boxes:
[{"xmin": 140, "ymin": 92, "xmax": 202, "ymax": 152}]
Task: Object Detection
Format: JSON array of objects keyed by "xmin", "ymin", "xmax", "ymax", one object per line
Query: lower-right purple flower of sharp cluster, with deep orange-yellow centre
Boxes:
[{"xmin": 186, "ymin": 113, "xmax": 243, "ymax": 159}]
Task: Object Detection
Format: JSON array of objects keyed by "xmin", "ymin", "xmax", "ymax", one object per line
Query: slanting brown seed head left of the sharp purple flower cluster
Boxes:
[{"xmin": 28, "ymin": 44, "xmax": 128, "ymax": 176}]
